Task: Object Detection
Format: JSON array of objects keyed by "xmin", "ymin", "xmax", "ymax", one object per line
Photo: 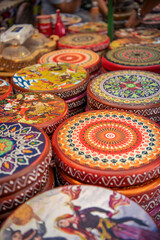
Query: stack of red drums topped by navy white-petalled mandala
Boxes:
[{"xmin": 0, "ymin": 122, "xmax": 54, "ymax": 223}]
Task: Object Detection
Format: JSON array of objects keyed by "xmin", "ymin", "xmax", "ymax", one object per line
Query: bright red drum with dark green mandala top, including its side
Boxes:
[{"xmin": 102, "ymin": 46, "xmax": 160, "ymax": 73}]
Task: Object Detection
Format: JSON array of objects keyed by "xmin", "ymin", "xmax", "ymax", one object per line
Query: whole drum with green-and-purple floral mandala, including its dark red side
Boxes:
[{"xmin": 87, "ymin": 70, "xmax": 160, "ymax": 122}]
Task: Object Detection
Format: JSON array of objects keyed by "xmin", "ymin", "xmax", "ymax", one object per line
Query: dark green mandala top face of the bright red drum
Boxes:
[{"xmin": 105, "ymin": 46, "xmax": 160, "ymax": 66}]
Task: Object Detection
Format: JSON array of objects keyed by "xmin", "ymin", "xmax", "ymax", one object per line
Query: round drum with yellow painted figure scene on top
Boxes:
[{"xmin": 12, "ymin": 63, "xmax": 89, "ymax": 99}]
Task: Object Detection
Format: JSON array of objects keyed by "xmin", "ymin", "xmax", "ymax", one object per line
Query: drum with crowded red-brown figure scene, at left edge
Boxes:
[{"xmin": 0, "ymin": 92, "xmax": 68, "ymax": 135}]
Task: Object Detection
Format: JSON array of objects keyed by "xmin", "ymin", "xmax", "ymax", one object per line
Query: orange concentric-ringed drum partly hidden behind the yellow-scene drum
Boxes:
[{"xmin": 39, "ymin": 49, "xmax": 101, "ymax": 73}]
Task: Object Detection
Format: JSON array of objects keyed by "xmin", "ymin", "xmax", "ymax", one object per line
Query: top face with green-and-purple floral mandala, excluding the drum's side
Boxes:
[{"xmin": 88, "ymin": 70, "xmax": 160, "ymax": 106}]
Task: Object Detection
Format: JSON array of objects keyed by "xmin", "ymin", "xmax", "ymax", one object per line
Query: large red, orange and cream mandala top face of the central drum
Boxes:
[{"xmin": 57, "ymin": 110, "xmax": 160, "ymax": 170}]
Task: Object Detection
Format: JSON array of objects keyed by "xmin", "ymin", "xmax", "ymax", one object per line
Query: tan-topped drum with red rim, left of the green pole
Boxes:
[{"xmin": 58, "ymin": 33, "xmax": 110, "ymax": 51}]
